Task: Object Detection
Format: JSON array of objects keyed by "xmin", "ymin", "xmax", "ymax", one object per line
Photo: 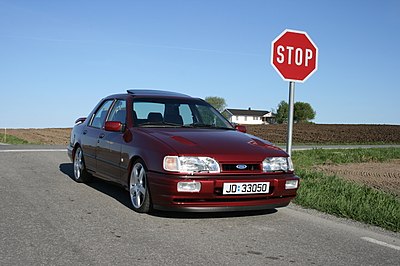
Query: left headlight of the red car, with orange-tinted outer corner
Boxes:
[{"xmin": 163, "ymin": 156, "xmax": 220, "ymax": 173}]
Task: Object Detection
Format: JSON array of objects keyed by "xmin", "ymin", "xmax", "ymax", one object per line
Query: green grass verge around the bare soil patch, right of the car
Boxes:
[{"xmin": 293, "ymin": 148, "xmax": 400, "ymax": 232}]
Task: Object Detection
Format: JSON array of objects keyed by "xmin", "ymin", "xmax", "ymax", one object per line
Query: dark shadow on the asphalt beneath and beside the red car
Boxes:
[{"xmin": 59, "ymin": 163, "xmax": 277, "ymax": 219}]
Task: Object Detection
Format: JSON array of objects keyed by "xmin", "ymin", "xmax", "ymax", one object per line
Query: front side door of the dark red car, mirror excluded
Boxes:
[{"xmin": 96, "ymin": 99, "xmax": 126, "ymax": 182}]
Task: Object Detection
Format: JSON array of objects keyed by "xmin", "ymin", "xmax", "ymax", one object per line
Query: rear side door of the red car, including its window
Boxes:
[{"xmin": 81, "ymin": 100, "xmax": 114, "ymax": 172}]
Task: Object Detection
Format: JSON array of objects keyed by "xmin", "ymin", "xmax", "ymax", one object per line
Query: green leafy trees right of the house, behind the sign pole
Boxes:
[{"xmin": 276, "ymin": 101, "xmax": 316, "ymax": 124}]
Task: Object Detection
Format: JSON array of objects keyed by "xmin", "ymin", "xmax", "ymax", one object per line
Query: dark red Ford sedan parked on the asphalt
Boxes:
[{"xmin": 68, "ymin": 90, "xmax": 299, "ymax": 212}]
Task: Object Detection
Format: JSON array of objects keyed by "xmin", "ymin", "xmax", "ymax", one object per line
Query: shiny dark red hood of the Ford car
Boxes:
[{"xmin": 141, "ymin": 128, "xmax": 288, "ymax": 162}]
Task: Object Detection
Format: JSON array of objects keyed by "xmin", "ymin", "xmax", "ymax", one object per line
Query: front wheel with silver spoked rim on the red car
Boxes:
[{"xmin": 129, "ymin": 160, "xmax": 152, "ymax": 213}]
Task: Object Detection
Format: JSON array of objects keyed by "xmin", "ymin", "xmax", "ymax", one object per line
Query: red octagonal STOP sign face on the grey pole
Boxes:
[{"xmin": 271, "ymin": 30, "xmax": 318, "ymax": 82}]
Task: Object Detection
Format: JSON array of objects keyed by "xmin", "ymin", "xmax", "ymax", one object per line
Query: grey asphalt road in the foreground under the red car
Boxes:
[{"xmin": 0, "ymin": 146, "xmax": 400, "ymax": 265}]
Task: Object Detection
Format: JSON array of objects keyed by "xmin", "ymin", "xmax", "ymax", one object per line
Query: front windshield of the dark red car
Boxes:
[{"xmin": 133, "ymin": 99, "xmax": 233, "ymax": 129}]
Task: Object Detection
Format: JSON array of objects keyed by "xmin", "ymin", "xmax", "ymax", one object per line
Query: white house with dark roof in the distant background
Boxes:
[{"xmin": 222, "ymin": 107, "xmax": 275, "ymax": 125}]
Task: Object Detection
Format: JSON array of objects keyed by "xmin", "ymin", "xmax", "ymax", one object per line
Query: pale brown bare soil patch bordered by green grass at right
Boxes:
[{"xmin": 316, "ymin": 160, "xmax": 400, "ymax": 197}]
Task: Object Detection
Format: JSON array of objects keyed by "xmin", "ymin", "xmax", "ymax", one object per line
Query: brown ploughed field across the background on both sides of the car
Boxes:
[{"xmin": 0, "ymin": 124, "xmax": 400, "ymax": 145}]
